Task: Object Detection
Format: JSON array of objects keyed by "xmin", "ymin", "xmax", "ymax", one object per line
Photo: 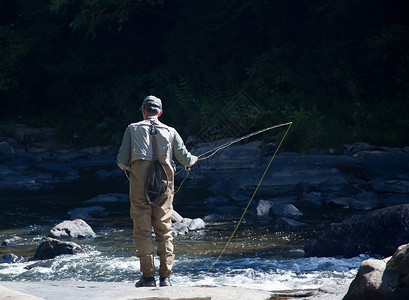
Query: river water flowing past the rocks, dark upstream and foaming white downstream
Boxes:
[{"xmin": 0, "ymin": 165, "xmax": 368, "ymax": 290}]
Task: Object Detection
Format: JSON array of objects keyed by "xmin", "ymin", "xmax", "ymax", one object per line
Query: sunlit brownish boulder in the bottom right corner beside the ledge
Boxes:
[{"xmin": 343, "ymin": 244, "xmax": 409, "ymax": 300}]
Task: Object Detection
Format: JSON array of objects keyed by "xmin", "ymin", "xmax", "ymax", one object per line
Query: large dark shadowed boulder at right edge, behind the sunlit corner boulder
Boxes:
[{"xmin": 304, "ymin": 204, "xmax": 409, "ymax": 257}]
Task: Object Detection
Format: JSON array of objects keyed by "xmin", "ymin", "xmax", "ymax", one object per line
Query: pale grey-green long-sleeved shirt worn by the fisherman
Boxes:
[{"xmin": 117, "ymin": 117, "xmax": 196, "ymax": 169}]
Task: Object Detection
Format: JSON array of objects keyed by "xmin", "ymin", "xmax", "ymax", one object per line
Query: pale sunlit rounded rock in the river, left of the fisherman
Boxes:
[{"xmin": 48, "ymin": 219, "xmax": 96, "ymax": 239}]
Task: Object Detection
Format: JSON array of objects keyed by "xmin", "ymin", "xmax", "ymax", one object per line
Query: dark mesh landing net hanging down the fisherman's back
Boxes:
[{"xmin": 145, "ymin": 122, "xmax": 169, "ymax": 205}]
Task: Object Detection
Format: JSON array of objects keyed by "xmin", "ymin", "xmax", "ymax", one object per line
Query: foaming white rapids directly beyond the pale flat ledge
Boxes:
[{"xmin": 0, "ymin": 243, "xmax": 368, "ymax": 290}]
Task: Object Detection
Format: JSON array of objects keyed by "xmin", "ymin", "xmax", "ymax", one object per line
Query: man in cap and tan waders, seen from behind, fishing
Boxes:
[{"xmin": 117, "ymin": 96, "xmax": 197, "ymax": 287}]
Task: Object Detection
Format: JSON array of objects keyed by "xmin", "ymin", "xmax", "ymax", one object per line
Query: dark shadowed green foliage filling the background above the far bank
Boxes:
[{"xmin": 0, "ymin": 0, "xmax": 409, "ymax": 153}]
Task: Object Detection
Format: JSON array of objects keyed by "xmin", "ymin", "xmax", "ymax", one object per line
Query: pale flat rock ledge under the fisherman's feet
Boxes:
[{"xmin": 0, "ymin": 281, "xmax": 348, "ymax": 300}]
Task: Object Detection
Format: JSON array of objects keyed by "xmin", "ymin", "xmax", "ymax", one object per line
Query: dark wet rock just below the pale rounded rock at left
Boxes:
[{"xmin": 34, "ymin": 237, "xmax": 85, "ymax": 259}]
